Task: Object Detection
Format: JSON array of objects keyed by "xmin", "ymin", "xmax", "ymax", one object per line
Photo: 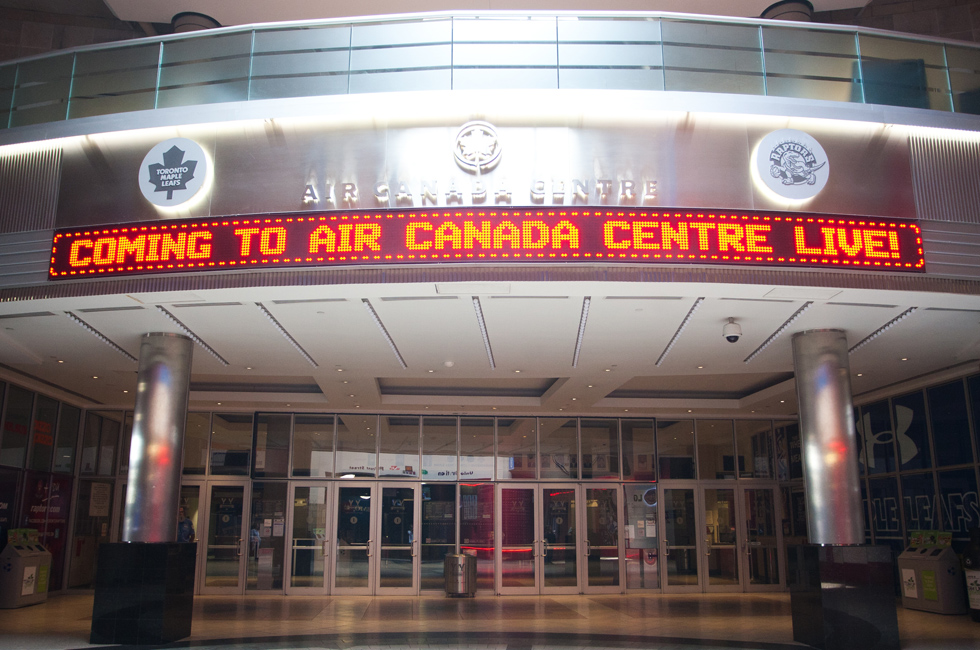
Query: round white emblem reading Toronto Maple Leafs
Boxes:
[{"xmin": 139, "ymin": 138, "xmax": 208, "ymax": 208}]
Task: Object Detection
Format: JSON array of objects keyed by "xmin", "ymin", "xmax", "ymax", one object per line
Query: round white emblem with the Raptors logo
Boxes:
[{"xmin": 755, "ymin": 129, "xmax": 830, "ymax": 201}]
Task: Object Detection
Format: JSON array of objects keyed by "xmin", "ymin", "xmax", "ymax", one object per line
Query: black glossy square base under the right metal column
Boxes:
[{"xmin": 787, "ymin": 544, "xmax": 899, "ymax": 650}]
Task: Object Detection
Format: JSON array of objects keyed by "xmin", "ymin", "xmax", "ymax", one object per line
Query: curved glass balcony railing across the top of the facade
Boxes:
[{"xmin": 0, "ymin": 13, "xmax": 980, "ymax": 128}]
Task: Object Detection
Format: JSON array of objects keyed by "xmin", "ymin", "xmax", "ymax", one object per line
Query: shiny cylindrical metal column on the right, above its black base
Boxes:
[{"xmin": 793, "ymin": 330, "xmax": 864, "ymax": 544}]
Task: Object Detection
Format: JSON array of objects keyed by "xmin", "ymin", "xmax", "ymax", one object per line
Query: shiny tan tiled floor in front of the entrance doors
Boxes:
[{"xmin": 0, "ymin": 593, "xmax": 980, "ymax": 650}]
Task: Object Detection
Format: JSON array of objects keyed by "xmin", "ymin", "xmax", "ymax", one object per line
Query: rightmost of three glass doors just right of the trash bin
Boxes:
[{"xmin": 578, "ymin": 485, "xmax": 625, "ymax": 593}]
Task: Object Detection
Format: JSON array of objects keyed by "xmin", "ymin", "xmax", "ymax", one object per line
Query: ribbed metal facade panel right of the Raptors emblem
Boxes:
[{"xmin": 909, "ymin": 133, "xmax": 980, "ymax": 223}]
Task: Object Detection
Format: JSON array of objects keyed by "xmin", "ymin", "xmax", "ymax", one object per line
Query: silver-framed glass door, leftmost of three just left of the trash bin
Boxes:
[{"xmin": 285, "ymin": 483, "xmax": 334, "ymax": 595}]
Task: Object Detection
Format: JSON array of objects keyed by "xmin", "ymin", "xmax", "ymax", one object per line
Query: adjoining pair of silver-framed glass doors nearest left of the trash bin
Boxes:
[{"xmin": 331, "ymin": 483, "xmax": 419, "ymax": 595}]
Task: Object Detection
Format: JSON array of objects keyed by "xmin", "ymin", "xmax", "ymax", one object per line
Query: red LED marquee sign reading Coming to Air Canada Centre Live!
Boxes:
[{"xmin": 49, "ymin": 208, "xmax": 925, "ymax": 280}]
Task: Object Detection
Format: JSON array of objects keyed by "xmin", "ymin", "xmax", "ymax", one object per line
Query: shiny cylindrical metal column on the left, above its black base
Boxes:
[{"xmin": 123, "ymin": 333, "xmax": 193, "ymax": 542}]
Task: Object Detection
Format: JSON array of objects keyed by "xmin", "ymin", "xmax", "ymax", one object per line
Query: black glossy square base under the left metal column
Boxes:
[{"xmin": 89, "ymin": 542, "xmax": 197, "ymax": 645}]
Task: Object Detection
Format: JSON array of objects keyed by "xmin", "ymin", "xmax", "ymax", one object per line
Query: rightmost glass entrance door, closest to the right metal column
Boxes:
[{"xmin": 739, "ymin": 486, "xmax": 784, "ymax": 591}]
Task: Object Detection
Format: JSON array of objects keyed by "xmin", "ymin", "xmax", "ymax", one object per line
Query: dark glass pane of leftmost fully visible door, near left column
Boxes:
[{"xmin": 204, "ymin": 480, "xmax": 245, "ymax": 587}]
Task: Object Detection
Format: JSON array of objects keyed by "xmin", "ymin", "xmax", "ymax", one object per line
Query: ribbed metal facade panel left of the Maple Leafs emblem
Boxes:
[{"xmin": 0, "ymin": 146, "xmax": 61, "ymax": 233}]
